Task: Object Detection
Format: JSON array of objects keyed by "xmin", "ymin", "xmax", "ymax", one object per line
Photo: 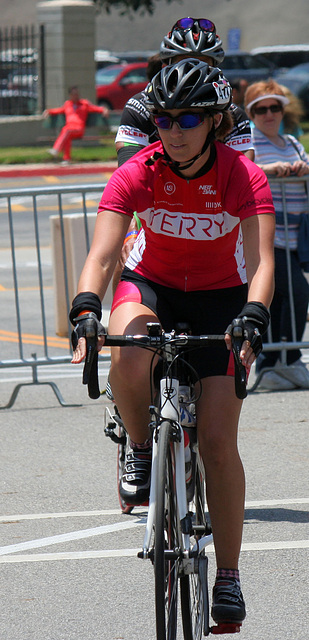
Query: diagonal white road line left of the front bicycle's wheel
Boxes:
[{"xmin": 0, "ymin": 519, "xmax": 145, "ymax": 556}]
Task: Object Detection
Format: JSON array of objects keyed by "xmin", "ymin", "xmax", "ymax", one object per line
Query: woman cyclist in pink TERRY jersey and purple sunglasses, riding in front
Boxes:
[{"xmin": 70, "ymin": 59, "xmax": 274, "ymax": 624}]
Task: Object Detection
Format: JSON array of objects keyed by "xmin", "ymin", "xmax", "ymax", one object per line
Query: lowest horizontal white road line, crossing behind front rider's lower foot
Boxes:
[{"xmin": 0, "ymin": 540, "xmax": 309, "ymax": 564}]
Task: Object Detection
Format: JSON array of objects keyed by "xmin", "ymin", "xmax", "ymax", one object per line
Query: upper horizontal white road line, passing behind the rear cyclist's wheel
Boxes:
[{"xmin": 0, "ymin": 498, "xmax": 309, "ymax": 522}]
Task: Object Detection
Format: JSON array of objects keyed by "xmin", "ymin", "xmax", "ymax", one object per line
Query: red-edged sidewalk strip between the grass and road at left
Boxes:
[{"xmin": 0, "ymin": 160, "xmax": 118, "ymax": 180}]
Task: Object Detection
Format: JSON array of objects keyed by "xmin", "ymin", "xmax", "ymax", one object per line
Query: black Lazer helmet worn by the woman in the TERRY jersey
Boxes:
[{"xmin": 145, "ymin": 58, "xmax": 232, "ymax": 112}]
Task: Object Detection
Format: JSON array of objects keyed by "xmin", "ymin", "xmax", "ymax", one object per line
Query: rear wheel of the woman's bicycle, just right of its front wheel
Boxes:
[{"xmin": 180, "ymin": 455, "xmax": 211, "ymax": 640}]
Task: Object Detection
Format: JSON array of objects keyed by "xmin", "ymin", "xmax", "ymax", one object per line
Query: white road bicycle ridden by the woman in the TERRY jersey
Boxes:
[{"xmin": 84, "ymin": 321, "xmax": 246, "ymax": 640}]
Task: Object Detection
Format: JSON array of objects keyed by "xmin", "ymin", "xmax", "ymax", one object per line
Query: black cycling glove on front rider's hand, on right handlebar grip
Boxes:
[{"xmin": 225, "ymin": 302, "xmax": 270, "ymax": 357}]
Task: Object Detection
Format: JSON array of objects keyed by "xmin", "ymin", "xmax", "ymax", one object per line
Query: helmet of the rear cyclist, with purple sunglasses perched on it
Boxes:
[{"xmin": 160, "ymin": 18, "xmax": 224, "ymax": 65}]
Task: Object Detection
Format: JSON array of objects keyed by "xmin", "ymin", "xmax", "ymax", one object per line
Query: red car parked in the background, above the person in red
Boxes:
[{"xmin": 95, "ymin": 62, "xmax": 148, "ymax": 110}]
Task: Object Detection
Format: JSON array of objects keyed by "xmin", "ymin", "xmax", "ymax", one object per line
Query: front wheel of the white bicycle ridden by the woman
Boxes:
[{"xmin": 154, "ymin": 422, "xmax": 181, "ymax": 640}]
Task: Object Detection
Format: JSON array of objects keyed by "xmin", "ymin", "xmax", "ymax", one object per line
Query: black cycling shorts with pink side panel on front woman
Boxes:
[{"xmin": 112, "ymin": 268, "xmax": 248, "ymax": 378}]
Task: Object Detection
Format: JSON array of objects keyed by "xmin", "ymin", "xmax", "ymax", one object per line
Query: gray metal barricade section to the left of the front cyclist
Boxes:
[{"xmin": 0, "ymin": 183, "xmax": 109, "ymax": 409}]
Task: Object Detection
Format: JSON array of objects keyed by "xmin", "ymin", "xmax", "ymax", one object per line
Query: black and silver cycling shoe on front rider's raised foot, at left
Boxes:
[{"xmin": 119, "ymin": 447, "xmax": 152, "ymax": 505}]
